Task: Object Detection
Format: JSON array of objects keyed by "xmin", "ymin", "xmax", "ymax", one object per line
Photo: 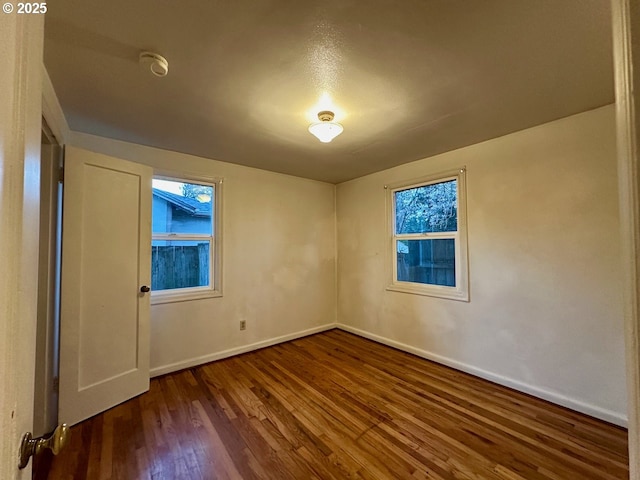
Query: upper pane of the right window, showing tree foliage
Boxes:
[{"xmin": 394, "ymin": 180, "xmax": 458, "ymax": 234}]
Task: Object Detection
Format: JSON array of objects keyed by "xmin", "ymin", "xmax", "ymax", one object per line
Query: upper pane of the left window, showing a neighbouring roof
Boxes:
[{"xmin": 153, "ymin": 179, "xmax": 214, "ymax": 235}]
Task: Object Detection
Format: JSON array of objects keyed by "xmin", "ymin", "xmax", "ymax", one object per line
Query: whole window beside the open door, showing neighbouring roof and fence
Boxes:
[{"xmin": 151, "ymin": 177, "xmax": 221, "ymax": 303}]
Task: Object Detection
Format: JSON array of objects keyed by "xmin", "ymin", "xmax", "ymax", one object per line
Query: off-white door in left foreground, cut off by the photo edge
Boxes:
[{"xmin": 0, "ymin": 12, "xmax": 44, "ymax": 480}]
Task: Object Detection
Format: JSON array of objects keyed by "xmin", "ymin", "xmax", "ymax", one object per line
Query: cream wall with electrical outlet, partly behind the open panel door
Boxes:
[{"xmin": 68, "ymin": 132, "xmax": 336, "ymax": 375}]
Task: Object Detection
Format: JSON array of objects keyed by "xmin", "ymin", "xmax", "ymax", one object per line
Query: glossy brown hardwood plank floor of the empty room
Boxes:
[{"xmin": 49, "ymin": 330, "xmax": 628, "ymax": 480}]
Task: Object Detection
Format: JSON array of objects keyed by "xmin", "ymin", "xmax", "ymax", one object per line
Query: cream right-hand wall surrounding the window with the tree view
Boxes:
[{"xmin": 337, "ymin": 106, "xmax": 626, "ymax": 424}]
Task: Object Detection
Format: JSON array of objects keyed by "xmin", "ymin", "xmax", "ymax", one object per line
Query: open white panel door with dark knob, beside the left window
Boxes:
[{"xmin": 58, "ymin": 147, "xmax": 152, "ymax": 425}]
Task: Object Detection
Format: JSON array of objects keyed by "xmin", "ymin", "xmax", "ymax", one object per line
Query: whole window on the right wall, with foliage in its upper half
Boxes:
[{"xmin": 387, "ymin": 169, "xmax": 469, "ymax": 301}]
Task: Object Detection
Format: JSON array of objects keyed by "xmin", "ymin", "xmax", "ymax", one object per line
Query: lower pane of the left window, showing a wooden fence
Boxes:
[{"xmin": 151, "ymin": 240, "xmax": 211, "ymax": 291}]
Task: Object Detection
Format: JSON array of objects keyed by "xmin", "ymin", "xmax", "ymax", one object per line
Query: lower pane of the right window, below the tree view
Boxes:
[{"xmin": 396, "ymin": 238, "xmax": 456, "ymax": 287}]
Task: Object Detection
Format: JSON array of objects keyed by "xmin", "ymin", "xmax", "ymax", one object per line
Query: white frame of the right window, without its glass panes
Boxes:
[{"xmin": 384, "ymin": 167, "xmax": 469, "ymax": 302}]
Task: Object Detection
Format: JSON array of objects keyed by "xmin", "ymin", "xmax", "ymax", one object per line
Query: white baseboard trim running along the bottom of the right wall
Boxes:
[{"xmin": 335, "ymin": 323, "xmax": 628, "ymax": 427}]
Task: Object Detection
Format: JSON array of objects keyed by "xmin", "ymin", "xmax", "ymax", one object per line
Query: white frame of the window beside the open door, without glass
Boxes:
[{"xmin": 151, "ymin": 170, "xmax": 223, "ymax": 305}]
